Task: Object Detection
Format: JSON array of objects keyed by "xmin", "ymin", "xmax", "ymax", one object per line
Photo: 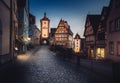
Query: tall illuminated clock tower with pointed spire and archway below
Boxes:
[{"xmin": 40, "ymin": 13, "xmax": 50, "ymax": 44}]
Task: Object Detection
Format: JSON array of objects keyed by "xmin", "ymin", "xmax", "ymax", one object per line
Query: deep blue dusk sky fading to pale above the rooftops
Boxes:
[{"xmin": 30, "ymin": 0, "xmax": 110, "ymax": 37}]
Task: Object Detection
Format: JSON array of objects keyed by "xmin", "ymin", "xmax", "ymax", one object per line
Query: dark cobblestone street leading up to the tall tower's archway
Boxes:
[{"xmin": 0, "ymin": 46, "xmax": 114, "ymax": 83}]
